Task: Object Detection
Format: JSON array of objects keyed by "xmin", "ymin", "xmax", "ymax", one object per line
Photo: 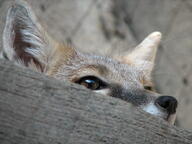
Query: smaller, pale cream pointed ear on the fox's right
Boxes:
[{"xmin": 119, "ymin": 32, "xmax": 161, "ymax": 71}]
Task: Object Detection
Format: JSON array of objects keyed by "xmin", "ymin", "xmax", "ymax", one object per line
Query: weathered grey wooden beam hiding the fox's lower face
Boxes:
[{"xmin": 0, "ymin": 60, "xmax": 192, "ymax": 144}]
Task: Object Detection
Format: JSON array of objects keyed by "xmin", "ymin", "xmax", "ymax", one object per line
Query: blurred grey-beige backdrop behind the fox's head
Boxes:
[{"xmin": 0, "ymin": 0, "xmax": 192, "ymax": 130}]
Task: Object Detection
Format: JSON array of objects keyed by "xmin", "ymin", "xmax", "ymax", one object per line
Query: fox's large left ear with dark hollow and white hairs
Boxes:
[{"xmin": 3, "ymin": 0, "xmax": 56, "ymax": 72}]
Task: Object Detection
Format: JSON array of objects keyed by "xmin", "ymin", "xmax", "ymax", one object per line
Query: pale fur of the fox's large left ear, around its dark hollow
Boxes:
[{"xmin": 3, "ymin": 0, "xmax": 56, "ymax": 72}]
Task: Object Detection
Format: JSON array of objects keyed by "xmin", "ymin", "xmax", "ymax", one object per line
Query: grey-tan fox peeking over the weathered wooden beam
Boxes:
[{"xmin": 1, "ymin": 0, "xmax": 177, "ymax": 124}]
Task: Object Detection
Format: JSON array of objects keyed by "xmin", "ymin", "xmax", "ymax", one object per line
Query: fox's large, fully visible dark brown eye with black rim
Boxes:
[{"xmin": 75, "ymin": 76, "xmax": 107, "ymax": 90}]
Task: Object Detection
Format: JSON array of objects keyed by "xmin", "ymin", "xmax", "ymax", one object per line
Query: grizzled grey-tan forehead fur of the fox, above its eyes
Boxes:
[{"xmin": 48, "ymin": 44, "xmax": 150, "ymax": 87}]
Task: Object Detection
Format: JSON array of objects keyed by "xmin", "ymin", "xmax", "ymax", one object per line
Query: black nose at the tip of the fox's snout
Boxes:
[{"xmin": 155, "ymin": 96, "xmax": 177, "ymax": 114}]
